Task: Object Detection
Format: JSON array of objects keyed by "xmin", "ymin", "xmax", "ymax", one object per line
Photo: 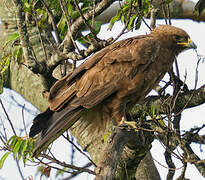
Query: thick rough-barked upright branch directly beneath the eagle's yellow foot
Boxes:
[{"xmin": 95, "ymin": 125, "xmax": 153, "ymax": 180}]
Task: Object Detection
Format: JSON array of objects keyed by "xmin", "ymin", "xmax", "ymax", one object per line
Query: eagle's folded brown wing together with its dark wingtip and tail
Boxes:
[{"xmin": 30, "ymin": 35, "xmax": 159, "ymax": 156}]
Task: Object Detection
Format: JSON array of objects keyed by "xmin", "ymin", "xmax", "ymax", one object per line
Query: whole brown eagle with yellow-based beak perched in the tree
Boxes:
[{"xmin": 29, "ymin": 25, "xmax": 196, "ymax": 155}]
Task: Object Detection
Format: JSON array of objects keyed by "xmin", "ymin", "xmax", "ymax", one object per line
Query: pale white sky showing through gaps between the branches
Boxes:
[{"xmin": 0, "ymin": 8, "xmax": 205, "ymax": 180}]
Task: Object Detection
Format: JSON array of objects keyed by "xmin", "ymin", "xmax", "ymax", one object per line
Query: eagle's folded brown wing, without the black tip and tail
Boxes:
[{"xmin": 49, "ymin": 35, "xmax": 158, "ymax": 111}]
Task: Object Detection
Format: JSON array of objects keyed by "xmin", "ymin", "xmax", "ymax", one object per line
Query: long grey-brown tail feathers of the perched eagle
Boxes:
[{"xmin": 29, "ymin": 106, "xmax": 84, "ymax": 156}]
